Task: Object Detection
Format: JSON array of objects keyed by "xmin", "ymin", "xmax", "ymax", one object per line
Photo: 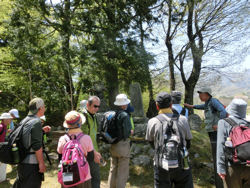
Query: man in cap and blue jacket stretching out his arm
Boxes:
[{"xmin": 184, "ymin": 87, "xmax": 227, "ymax": 188}]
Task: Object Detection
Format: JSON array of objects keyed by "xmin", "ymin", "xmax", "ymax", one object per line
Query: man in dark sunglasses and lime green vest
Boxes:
[{"xmin": 82, "ymin": 96, "xmax": 102, "ymax": 188}]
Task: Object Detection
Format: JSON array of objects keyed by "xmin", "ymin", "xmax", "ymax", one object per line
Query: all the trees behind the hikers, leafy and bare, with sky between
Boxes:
[{"xmin": 0, "ymin": 0, "xmax": 250, "ymax": 124}]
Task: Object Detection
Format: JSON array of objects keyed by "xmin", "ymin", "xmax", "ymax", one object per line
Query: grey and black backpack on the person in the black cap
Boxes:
[{"xmin": 155, "ymin": 114, "xmax": 184, "ymax": 171}]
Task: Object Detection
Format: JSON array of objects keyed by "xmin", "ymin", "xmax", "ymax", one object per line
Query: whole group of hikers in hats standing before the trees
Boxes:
[{"xmin": 0, "ymin": 87, "xmax": 250, "ymax": 188}]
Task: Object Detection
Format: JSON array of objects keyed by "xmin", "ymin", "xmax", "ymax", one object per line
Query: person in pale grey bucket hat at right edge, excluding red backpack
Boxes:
[{"xmin": 217, "ymin": 98, "xmax": 250, "ymax": 188}]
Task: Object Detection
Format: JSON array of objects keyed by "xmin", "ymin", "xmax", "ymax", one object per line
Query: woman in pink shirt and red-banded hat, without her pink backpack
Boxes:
[{"xmin": 57, "ymin": 111, "xmax": 94, "ymax": 188}]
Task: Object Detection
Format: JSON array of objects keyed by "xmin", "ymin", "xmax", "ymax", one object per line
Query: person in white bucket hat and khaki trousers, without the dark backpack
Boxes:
[{"xmin": 108, "ymin": 94, "xmax": 131, "ymax": 188}]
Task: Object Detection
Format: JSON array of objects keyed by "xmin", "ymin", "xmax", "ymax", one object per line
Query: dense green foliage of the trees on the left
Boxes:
[{"xmin": 0, "ymin": 0, "xmax": 155, "ymax": 117}]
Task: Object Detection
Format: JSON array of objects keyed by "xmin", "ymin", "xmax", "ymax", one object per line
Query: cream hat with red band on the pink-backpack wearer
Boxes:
[{"xmin": 63, "ymin": 111, "xmax": 86, "ymax": 128}]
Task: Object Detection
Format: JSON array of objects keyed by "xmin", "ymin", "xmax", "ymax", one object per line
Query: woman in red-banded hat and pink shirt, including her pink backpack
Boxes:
[{"xmin": 57, "ymin": 111, "xmax": 94, "ymax": 188}]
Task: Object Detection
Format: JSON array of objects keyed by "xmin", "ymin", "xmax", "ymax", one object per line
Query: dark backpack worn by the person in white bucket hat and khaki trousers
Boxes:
[{"xmin": 98, "ymin": 110, "xmax": 123, "ymax": 144}]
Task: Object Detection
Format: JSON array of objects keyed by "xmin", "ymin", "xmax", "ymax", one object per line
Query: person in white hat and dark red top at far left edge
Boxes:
[{"xmin": 0, "ymin": 113, "xmax": 12, "ymax": 182}]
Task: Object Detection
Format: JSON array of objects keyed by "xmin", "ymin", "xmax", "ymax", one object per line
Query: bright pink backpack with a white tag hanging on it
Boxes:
[{"xmin": 58, "ymin": 133, "xmax": 89, "ymax": 187}]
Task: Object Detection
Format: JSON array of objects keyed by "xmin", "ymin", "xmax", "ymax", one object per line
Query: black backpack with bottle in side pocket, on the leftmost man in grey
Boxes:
[{"xmin": 0, "ymin": 118, "xmax": 32, "ymax": 164}]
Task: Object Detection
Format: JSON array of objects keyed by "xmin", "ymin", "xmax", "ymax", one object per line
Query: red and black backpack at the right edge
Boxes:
[{"xmin": 224, "ymin": 118, "xmax": 250, "ymax": 165}]
